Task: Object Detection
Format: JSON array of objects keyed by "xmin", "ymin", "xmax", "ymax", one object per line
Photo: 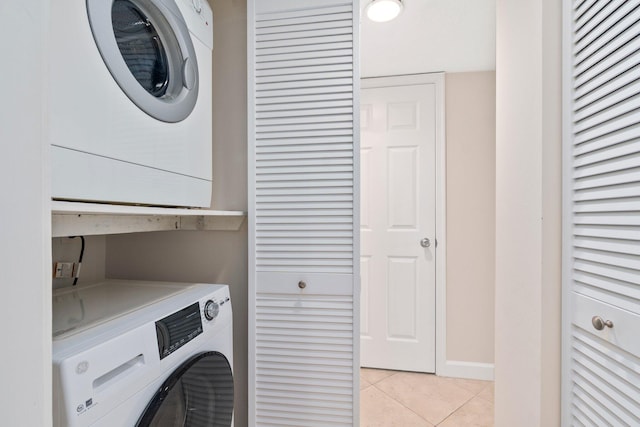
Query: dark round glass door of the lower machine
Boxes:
[{"xmin": 136, "ymin": 351, "xmax": 233, "ymax": 427}]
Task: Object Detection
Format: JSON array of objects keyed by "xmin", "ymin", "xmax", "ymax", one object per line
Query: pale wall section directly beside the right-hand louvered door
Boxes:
[{"xmin": 495, "ymin": 0, "xmax": 561, "ymax": 427}]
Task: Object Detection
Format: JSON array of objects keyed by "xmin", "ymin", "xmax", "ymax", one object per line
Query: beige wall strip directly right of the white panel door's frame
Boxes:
[{"xmin": 445, "ymin": 71, "xmax": 496, "ymax": 366}]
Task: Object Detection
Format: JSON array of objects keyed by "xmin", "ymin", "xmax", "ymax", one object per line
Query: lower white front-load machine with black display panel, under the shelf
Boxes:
[{"xmin": 53, "ymin": 281, "xmax": 234, "ymax": 427}]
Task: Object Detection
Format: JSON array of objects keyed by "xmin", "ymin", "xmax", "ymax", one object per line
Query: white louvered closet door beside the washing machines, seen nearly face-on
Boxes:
[{"xmin": 248, "ymin": 0, "xmax": 359, "ymax": 427}]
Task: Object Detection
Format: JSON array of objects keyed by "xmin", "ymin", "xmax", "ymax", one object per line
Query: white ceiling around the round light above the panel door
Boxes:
[{"xmin": 360, "ymin": 0, "xmax": 496, "ymax": 77}]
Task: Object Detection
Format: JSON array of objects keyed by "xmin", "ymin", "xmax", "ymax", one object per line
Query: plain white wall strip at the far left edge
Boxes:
[{"xmin": 0, "ymin": 0, "xmax": 51, "ymax": 427}]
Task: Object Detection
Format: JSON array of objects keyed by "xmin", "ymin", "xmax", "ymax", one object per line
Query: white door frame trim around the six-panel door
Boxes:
[{"xmin": 358, "ymin": 72, "xmax": 444, "ymax": 376}]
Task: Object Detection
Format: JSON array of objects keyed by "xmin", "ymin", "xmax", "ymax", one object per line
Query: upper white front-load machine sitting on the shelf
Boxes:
[{"xmin": 48, "ymin": 0, "xmax": 213, "ymax": 207}]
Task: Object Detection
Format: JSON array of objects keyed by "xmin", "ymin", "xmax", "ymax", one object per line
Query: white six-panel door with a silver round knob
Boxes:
[{"xmin": 360, "ymin": 75, "xmax": 441, "ymax": 372}]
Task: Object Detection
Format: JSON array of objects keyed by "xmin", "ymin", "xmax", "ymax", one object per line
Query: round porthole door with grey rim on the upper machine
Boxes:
[{"xmin": 87, "ymin": 0, "xmax": 198, "ymax": 123}]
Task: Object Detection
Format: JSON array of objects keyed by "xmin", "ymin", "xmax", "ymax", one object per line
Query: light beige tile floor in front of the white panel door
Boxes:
[{"xmin": 360, "ymin": 368, "xmax": 493, "ymax": 427}]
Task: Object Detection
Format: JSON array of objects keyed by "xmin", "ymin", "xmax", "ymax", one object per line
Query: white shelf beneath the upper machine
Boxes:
[{"xmin": 51, "ymin": 201, "xmax": 246, "ymax": 237}]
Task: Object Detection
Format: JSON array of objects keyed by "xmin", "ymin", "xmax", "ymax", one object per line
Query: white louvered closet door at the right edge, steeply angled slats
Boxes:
[{"xmin": 563, "ymin": 0, "xmax": 640, "ymax": 427}]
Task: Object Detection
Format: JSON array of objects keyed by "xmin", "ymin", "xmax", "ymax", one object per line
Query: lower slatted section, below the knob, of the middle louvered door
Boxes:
[{"xmin": 256, "ymin": 295, "xmax": 353, "ymax": 426}]
